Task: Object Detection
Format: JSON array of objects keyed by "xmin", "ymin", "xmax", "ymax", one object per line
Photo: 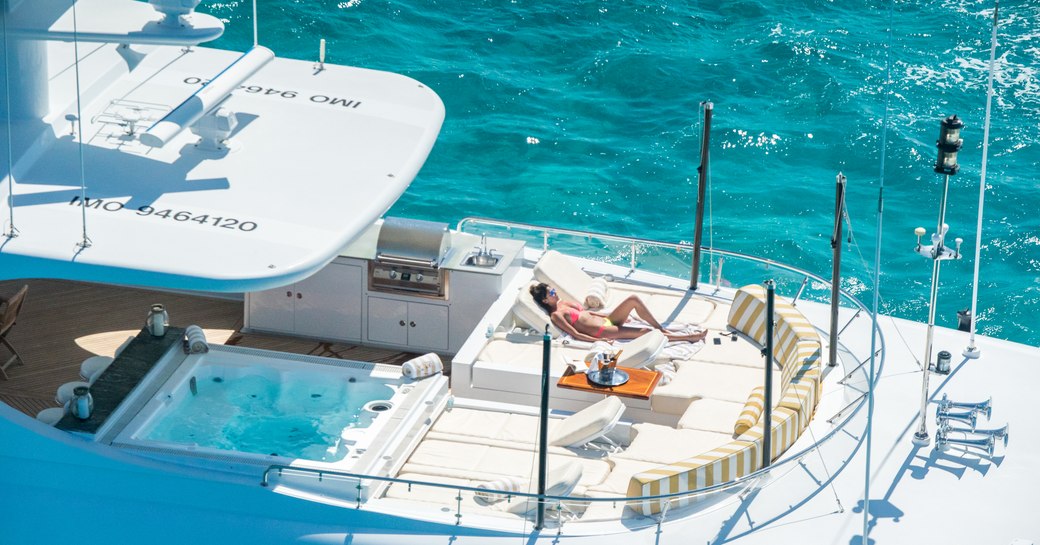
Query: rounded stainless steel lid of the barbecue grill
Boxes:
[{"xmin": 375, "ymin": 217, "xmax": 450, "ymax": 266}]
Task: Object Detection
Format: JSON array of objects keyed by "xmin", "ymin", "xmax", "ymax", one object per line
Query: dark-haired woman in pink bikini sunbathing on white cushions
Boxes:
[{"xmin": 530, "ymin": 283, "xmax": 707, "ymax": 342}]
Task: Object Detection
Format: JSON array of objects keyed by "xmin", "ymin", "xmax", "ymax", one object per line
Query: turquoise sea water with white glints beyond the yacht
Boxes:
[{"xmin": 200, "ymin": 0, "xmax": 1040, "ymax": 351}]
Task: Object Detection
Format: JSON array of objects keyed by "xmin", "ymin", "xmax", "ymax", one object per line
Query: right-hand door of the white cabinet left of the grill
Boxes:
[{"xmin": 295, "ymin": 261, "xmax": 362, "ymax": 340}]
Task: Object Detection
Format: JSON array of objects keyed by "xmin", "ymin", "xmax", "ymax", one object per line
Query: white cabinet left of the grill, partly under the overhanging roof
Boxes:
[{"xmin": 245, "ymin": 261, "xmax": 364, "ymax": 341}]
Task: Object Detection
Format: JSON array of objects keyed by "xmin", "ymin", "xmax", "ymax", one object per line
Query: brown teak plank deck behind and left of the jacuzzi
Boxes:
[{"xmin": 0, "ymin": 280, "xmax": 434, "ymax": 416}]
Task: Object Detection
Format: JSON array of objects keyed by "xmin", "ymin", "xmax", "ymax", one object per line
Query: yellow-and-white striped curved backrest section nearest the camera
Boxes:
[{"xmin": 628, "ymin": 441, "xmax": 762, "ymax": 515}]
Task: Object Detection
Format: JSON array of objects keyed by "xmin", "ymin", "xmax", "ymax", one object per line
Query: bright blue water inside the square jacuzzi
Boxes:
[{"xmin": 140, "ymin": 366, "xmax": 394, "ymax": 462}]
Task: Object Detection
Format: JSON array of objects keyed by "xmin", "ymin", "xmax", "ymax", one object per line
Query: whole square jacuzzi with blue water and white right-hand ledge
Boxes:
[{"xmin": 107, "ymin": 345, "xmax": 447, "ymax": 488}]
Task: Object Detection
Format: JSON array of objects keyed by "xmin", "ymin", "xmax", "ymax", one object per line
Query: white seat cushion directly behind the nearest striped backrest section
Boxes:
[{"xmin": 612, "ymin": 422, "xmax": 733, "ymax": 464}]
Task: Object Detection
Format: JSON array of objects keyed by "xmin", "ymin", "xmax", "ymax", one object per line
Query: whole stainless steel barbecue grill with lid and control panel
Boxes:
[{"xmin": 368, "ymin": 217, "xmax": 451, "ymax": 299}]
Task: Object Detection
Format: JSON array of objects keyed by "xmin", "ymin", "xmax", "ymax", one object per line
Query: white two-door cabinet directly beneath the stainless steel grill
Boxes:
[{"xmin": 367, "ymin": 295, "xmax": 448, "ymax": 351}]
